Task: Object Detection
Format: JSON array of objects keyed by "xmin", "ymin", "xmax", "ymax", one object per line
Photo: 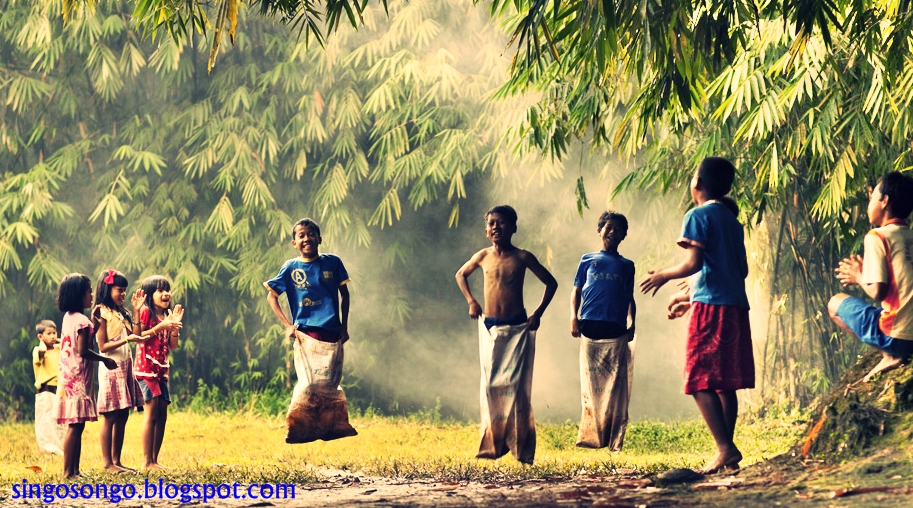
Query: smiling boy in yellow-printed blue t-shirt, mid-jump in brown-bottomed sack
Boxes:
[{"xmin": 263, "ymin": 218, "xmax": 357, "ymax": 443}]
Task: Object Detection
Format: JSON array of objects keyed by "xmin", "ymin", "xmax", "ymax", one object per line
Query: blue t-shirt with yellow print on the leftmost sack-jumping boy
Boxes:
[{"xmin": 263, "ymin": 254, "xmax": 349, "ymax": 332}]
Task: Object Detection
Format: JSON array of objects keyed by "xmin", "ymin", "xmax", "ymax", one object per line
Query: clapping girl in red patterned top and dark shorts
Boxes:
[{"xmin": 132, "ymin": 275, "xmax": 184, "ymax": 469}]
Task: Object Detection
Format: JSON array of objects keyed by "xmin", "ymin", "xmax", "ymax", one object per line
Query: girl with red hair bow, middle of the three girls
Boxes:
[{"xmin": 92, "ymin": 270, "xmax": 145, "ymax": 473}]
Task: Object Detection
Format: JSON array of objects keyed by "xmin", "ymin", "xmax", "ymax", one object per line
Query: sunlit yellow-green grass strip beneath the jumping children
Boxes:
[{"xmin": 0, "ymin": 412, "xmax": 802, "ymax": 491}]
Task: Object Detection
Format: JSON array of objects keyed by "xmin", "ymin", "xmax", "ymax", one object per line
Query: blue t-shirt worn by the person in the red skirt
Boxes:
[{"xmin": 678, "ymin": 200, "xmax": 748, "ymax": 309}]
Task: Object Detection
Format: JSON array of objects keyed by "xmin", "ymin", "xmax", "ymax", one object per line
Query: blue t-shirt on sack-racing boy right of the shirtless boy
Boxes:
[{"xmin": 574, "ymin": 250, "xmax": 634, "ymax": 327}]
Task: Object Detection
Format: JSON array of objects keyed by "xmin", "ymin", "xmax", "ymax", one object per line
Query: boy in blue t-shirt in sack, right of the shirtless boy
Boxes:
[{"xmin": 571, "ymin": 212, "xmax": 636, "ymax": 451}]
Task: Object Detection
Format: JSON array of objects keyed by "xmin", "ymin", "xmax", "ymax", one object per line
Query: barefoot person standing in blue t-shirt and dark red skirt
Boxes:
[{"xmin": 640, "ymin": 157, "xmax": 754, "ymax": 474}]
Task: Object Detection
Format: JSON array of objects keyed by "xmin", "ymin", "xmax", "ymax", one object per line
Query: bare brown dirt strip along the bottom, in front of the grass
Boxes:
[{"xmin": 7, "ymin": 451, "xmax": 913, "ymax": 508}]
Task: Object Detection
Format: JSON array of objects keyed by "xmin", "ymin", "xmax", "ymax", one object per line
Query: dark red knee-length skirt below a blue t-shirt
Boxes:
[{"xmin": 684, "ymin": 302, "xmax": 754, "ymax": 395}]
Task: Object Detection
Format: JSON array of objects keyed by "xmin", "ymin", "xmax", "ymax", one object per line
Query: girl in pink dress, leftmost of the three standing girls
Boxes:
[{"xmin": 57, "ymin": 273, "xmax": 117, "ymax": 478}]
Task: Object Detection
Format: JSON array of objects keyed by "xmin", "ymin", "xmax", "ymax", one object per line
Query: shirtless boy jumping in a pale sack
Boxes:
[{"xmin": 456, "ymin": 205, "xmax": 558, "ymax": 464}]
